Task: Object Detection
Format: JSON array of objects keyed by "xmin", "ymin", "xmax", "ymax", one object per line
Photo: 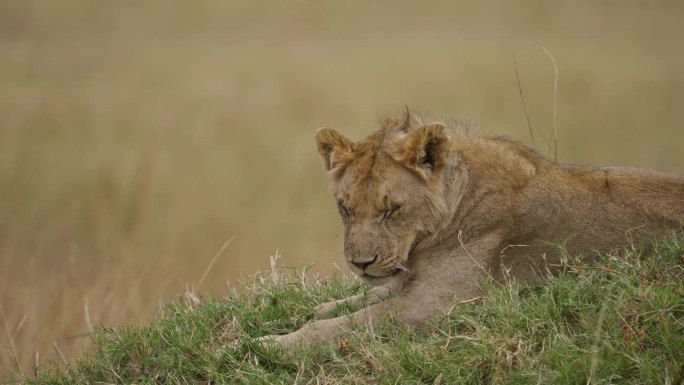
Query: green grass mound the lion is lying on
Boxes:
[{"xmin": 25, "ymin": 237, "xmax": 684, "ymax": 385}]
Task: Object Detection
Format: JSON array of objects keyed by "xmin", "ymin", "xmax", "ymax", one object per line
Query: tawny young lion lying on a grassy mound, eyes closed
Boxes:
[{"xmin": 262, "ymin": 109, "xmax": 684, "ymax": 347}]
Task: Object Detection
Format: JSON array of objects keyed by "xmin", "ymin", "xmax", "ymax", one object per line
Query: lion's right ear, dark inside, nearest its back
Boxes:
[{"xmin": 402, "ymin": 122, "xmax": 449, "ymax": 176}]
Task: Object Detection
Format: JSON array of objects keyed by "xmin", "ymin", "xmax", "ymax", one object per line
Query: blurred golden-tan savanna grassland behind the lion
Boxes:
[{"xmin": 0, "ymin": 0, "xmax": 684, "ymax": 378}]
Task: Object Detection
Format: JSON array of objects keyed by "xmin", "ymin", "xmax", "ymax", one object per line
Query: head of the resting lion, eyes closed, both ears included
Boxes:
[{"xmin": 316, "ymin": 111, "xmax": 460, "ymax": 284}]
